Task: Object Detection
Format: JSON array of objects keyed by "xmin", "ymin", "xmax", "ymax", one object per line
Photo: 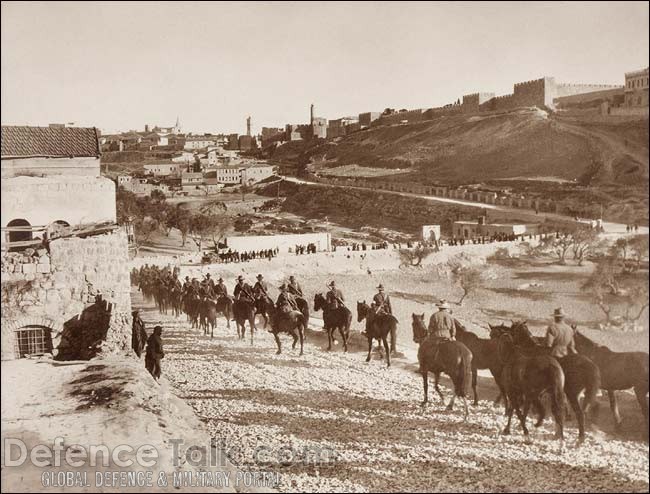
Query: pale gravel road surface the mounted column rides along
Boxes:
[{"xmin": 135, "ymin": 298, "xmax": 648, "ymax": 492}]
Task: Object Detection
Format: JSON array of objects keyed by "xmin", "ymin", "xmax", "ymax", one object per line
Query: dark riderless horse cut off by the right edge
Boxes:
[{"xmin": 572, "ymin": 326, "xmax": 648, "ymax": 433}]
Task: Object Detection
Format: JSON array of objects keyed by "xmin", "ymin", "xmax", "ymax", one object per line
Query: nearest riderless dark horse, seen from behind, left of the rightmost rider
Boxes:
[{"xmin": 498, "ymin": 333, "xmax": 564, "ymax": 442}]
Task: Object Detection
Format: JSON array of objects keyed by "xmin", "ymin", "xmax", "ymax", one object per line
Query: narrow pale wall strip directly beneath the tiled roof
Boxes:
[{"xmin": 1, "ymin": 156, "xmax": 99, "ymax": 178}]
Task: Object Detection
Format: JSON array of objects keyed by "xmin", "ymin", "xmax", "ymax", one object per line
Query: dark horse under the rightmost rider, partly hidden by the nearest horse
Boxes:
[{"xmin": 498, "ymin": 321, "xmax": 600, "ymax": 442}]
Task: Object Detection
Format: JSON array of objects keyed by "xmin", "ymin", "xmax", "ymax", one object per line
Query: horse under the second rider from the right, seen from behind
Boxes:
[{"xmin": 411, "ymin": 314, "xmax": 472, "ymax": 420}]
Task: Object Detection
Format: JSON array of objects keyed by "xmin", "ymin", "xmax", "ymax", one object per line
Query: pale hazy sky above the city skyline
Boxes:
[{"xmin": 2, "ymin": 2, "xmax": 649, "ymax": 133}]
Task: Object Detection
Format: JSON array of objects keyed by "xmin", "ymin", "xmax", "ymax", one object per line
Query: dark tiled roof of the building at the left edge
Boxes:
[{"xmin": 2, "ymin": 125, "xmax": 100, "ymax": 157}]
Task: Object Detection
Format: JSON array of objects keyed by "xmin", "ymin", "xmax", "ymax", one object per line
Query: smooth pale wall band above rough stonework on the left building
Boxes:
[{"xmin": 1, "ymin": 176, "xmax": 116, "ymax": 229}]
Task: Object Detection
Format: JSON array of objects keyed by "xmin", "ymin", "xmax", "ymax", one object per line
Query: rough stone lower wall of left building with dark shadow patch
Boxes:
[{"xmin": 1, "ymin": 230, "xmax": 131, "ymax": 360}]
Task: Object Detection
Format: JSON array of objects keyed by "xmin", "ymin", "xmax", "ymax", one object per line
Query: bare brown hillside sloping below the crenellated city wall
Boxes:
[{"xmin": 273, "ymin": 109, "xmax": 648, "ymax": 185}]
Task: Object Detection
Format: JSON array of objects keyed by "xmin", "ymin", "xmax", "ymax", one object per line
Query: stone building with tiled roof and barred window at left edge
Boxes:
[{"xmin": 0, "ymin": 126, "xmax": 131, "ymax": 359}]
